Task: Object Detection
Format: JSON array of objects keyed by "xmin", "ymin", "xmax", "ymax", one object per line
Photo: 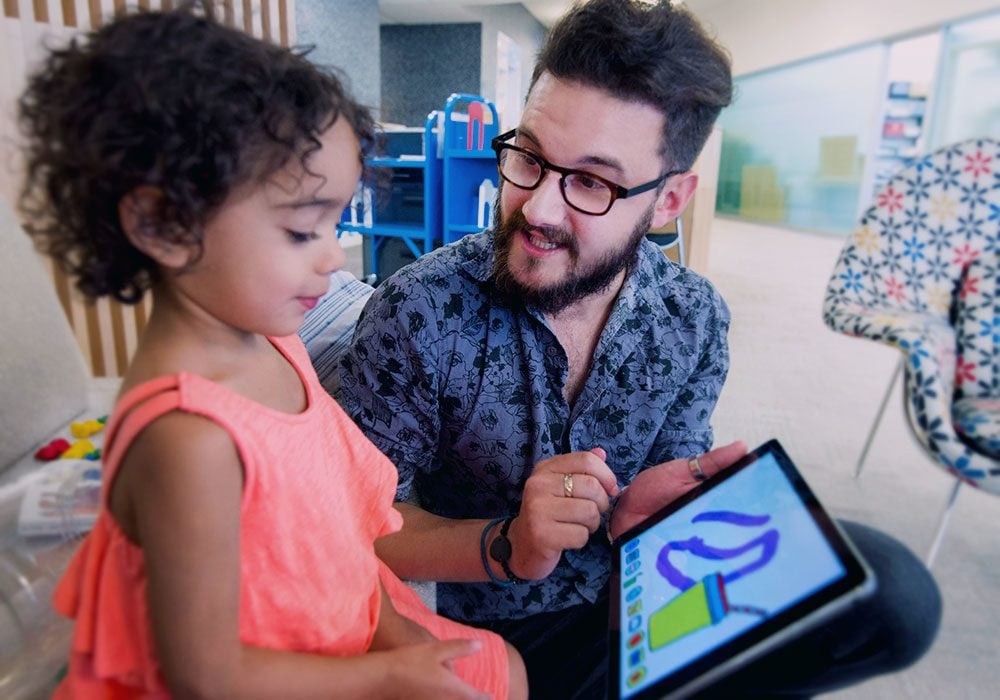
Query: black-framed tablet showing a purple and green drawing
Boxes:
[{"xmin": 608, "ymin": 440, "xmax": 875, "ymax": 700}]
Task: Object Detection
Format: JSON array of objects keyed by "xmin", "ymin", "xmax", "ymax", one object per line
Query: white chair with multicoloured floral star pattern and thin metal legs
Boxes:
[{"xmin": 823, "ymin": 139, "xmax": 1000, "ymax": 563}]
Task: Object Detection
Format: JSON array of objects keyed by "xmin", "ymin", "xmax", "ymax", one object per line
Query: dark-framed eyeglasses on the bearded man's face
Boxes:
[{"xmin": 491, "ymin": 129, "xmax": 684, "ymax": 216}]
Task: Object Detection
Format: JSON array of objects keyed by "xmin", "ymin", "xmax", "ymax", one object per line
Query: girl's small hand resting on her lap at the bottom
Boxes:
[{"xmin": 385, "ymin": 639, "xmax": 490, "ymax": 700}]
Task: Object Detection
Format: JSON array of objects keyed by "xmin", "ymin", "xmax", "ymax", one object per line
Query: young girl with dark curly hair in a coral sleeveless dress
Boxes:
[{"xmin": 20, "ymin": 10, "xmax": 527, "ymax": 698}]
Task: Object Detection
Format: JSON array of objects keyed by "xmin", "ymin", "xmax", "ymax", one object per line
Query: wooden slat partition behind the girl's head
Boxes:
[{"xmin": 0, "ymin": 0, "xmax": 295, "ymax": 376}]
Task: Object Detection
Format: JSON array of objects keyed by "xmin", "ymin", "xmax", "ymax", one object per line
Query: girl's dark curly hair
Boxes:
[{"xmin": 19, "ymin": 7, "xmax": 374, "ymax": 303}]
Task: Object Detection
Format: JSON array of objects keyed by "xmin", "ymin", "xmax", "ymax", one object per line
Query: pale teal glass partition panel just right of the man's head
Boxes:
[{"xmin": 716, "ymin": 44, "xmax": 887, "ymax": 233}]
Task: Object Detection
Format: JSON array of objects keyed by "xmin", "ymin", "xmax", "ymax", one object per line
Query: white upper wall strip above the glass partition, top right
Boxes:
[{"xmin": 691, "ymin": 0, "xmax": 997, "ymax": 75}]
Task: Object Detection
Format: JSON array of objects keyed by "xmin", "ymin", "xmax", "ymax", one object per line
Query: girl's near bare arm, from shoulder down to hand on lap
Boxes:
[{"xmin": 117, "ymin": 412, "xmax": 481, "ymax": 698}]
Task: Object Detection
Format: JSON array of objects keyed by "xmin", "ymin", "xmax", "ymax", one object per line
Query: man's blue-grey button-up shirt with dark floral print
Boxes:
[{"xmin": 337, "ymin": 232, "xmax": 729, "ymax": 620}]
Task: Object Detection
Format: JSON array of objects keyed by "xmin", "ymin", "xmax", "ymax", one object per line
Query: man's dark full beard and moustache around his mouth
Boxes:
[{"xmin": 491, "ymin": 206, "xmax": 655, "ymax": 314}]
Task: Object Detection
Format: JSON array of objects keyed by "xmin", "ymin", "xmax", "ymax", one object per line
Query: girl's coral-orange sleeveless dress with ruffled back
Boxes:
[{"xmin": 54, "ymin": 336, "xmax": 507, "ymax": 698}]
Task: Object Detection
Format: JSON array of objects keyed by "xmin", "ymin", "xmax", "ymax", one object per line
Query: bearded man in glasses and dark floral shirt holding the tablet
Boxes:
[{"xmin": 337, "ymin": 0, "xmax": 940, "ymax": 698}]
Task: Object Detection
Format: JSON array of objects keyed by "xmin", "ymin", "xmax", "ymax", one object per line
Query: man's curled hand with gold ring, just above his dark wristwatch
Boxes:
[{"xmin": 508, "ymin": 447, "xmax": 618, "ymax": 579}]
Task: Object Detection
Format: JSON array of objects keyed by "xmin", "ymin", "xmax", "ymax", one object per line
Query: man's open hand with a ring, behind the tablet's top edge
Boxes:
[{"xmin": 611, "ymin": 440, "xmax": 747, "ymax": 538}]
